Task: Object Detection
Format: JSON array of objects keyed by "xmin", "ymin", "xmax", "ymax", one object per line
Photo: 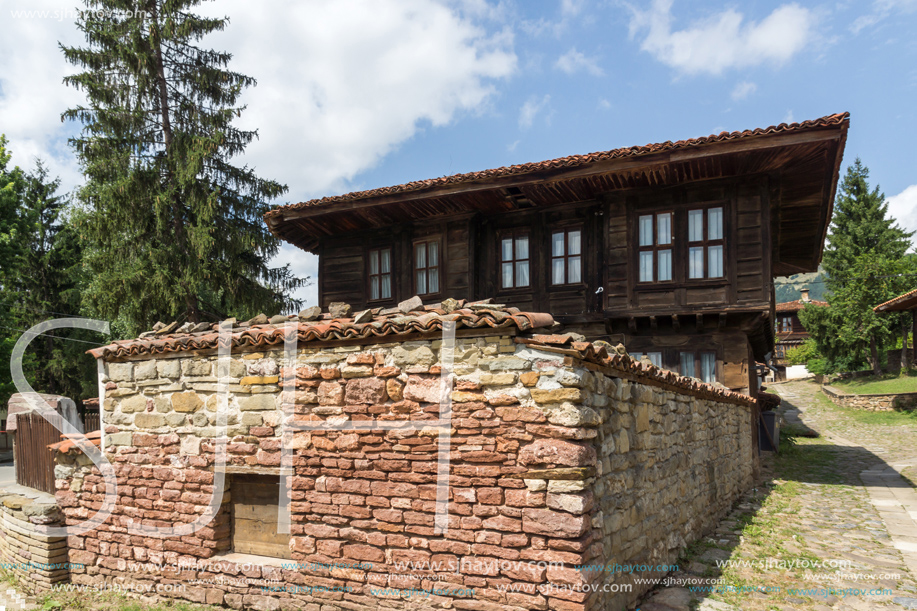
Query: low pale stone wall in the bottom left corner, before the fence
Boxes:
[{"xmin": 0, "ymin": 490, "xmax": 70, "ymax": 592}]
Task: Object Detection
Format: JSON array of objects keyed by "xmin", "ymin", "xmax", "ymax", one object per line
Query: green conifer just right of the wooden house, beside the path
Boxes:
[{"xmin": 799, "ymin": 159, "xmax": 917, "ymax": 373}]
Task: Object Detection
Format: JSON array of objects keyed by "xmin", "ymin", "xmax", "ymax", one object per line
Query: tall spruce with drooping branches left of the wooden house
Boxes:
[{"xmin": 62, "ymin": 0, "xmax": 305, "ymax": 334}]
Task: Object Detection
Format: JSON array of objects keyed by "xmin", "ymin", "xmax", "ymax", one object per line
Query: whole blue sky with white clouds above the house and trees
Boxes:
[{"xmin": 0, "ymin": 0, "xmax": 917, "ymax": 302}]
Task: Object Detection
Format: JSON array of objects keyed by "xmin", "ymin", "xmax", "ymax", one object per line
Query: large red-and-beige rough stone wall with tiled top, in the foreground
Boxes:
[{"xmin": 57, "ymin": 302, "xmax": 757, "ymax": 611}]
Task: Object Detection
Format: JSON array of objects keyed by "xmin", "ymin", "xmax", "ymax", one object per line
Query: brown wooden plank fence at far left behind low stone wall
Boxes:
[{"xmin": 13, "ymin": 412, "xmax": 99, "ymax": 494}]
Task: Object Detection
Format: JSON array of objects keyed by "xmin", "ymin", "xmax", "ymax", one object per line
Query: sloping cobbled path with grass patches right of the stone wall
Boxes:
[{"xmin": 637, "ymin": 382, "xmax": 917, "ymax": 611}]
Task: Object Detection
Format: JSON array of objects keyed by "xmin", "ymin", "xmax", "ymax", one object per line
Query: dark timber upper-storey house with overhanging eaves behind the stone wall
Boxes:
[{"xmin": 265, "ymin": 113, "xmax": 849, "ymax": 393}]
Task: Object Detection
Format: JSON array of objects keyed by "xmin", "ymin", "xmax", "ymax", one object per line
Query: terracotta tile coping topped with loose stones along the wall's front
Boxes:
[{"xmin": 88, "ymin": 299, "xmax": 554, "ymax": 359}]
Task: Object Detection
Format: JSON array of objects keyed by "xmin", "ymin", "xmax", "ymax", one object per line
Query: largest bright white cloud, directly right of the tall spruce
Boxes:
[{"xmin": 202, "ymin": 0, "xmax": 516, "ymax": 199}]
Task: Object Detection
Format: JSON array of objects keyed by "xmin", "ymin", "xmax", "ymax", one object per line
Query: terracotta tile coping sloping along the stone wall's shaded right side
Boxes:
[{"xmin": 516, "ymin": 335, "xmax": 755, "ymax": 405}]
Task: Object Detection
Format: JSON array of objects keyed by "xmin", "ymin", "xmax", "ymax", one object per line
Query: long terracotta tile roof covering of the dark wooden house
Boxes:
[{"xmin": 264, "ymin": 112, "xmax": 850, "ymax": 219}]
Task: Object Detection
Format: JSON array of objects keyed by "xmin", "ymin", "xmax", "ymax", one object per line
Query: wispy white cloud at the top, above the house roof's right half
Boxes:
[{"xmin": 630, "ymin": 0, "xmax": 815, "ymax": 75}]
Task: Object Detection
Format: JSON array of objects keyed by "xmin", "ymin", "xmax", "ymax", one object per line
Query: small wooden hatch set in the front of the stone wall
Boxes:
[{"xmin": 231, "ymin": 473, "xmax": 292, "ymax": 558}]
